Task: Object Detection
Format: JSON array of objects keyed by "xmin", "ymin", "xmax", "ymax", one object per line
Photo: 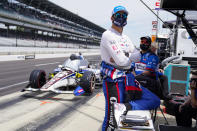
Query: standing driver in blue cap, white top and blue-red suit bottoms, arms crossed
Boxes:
[{"xmin": 100, "ymin": 6, "xmax": 160, "ymax": 131}]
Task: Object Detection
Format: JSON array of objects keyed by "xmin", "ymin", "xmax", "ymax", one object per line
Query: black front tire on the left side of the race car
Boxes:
[{"xmin": 29, "ymin": 70, "xmax": 46, "ymax": 89}]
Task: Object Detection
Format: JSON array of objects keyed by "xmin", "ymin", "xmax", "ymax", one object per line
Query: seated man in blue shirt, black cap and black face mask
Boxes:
[{"xmin": 131, "ymin": 36, "xmax": 163, "ymax": 98}]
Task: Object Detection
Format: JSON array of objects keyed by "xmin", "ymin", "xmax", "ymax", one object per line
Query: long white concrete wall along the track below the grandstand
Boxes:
[{"xmin": 0, "ymin": 47, "xmax": 100, "ymax": 61}]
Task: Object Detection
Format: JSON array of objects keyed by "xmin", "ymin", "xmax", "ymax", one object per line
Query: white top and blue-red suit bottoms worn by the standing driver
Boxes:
[{"xmin": 100, "ymin": 28, "xmax": 160, "ymax": 131}]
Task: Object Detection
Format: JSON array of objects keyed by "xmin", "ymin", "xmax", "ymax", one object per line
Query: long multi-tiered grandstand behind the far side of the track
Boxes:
[{"xmin": 0, "ymin": 0, "xmax": 105, "ymax": 48}]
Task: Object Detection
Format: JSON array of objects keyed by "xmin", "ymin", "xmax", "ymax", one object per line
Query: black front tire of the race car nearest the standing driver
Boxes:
[{"xmin": 79, "ymin": 71, "xmax": 96, "ymax": 94}]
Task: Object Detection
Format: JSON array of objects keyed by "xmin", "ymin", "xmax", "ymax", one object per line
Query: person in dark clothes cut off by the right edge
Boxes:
[{"xmin": 175, "ymin": 71, "xmax": 197, "ymax": 127}]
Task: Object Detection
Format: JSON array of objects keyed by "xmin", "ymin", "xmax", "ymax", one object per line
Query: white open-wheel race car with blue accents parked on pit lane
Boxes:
[{"xmin": 22, "ymin": 55, "xmax": 101, "ymax": 95}]
